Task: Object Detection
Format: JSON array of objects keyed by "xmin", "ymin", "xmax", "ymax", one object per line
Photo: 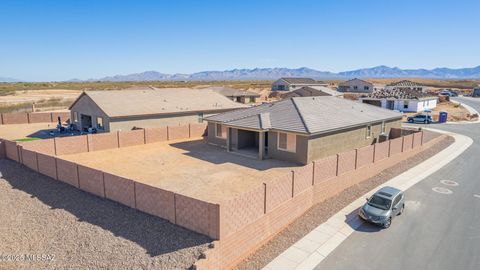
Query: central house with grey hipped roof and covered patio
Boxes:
[{"xmin": 205, "ymin": 96, "xmax": 402, "ymax": 164}]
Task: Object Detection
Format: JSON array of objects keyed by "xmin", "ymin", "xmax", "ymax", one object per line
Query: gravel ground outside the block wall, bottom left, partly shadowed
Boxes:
[{"xmin": 0, "ymin": 159, "xmax": 211, "ymax": 269}]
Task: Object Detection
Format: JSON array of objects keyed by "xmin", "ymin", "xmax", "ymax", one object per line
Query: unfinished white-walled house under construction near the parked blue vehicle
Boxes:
[{"xmin": 360, "ymin": 89, "xmax": 438, "ymax": 112}]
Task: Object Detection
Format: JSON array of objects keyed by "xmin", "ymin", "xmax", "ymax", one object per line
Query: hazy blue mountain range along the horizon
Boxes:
[{"xmin": 0, "ymin": 66, "xmax": 480, "ymax": 82}]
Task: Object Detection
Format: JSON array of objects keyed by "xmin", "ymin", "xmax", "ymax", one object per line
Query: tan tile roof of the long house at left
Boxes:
[{"xmin": 70, "ymin": 88, "xmax": 248, "ymax": 117}]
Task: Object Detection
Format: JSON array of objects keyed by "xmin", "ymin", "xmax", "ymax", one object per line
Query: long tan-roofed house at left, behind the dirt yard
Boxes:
[{"xmin": 69, "ymin": 88, "xmax": 247, "ymax": 132}]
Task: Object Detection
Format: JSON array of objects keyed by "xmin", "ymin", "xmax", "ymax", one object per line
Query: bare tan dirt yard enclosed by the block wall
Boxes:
[{"xmin": 61, "ymin": 139, "xmax": 296, "ymax": 203}]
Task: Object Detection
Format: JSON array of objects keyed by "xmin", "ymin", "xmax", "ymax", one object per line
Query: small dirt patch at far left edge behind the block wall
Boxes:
[{"xmin": 0, "ymin": 123, "xmax": 57, "ymax": 140}]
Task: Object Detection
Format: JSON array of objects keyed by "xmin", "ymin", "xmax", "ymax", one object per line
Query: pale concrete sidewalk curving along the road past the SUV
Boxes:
[{"xmin": 263, "ymin": 129, "xmax": 473, "ymax": 270}]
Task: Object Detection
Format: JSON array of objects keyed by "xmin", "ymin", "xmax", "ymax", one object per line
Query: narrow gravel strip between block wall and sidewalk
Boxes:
[{"xmin": 236, "ymin": 137, "xmax": 454, "ymax": 270}]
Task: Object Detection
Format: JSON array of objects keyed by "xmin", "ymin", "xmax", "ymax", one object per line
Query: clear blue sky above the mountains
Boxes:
[{"xmin": 0, "ymin": 0, "xmax": 480, "ymax": 81}]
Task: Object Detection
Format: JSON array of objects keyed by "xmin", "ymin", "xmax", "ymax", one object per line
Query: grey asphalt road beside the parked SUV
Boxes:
[{"xmin": 315, "ymin": 98, "xmax": 480, "ymax": 270}]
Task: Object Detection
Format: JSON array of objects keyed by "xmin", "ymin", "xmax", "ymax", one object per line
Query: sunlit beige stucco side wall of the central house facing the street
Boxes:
[{"xmin": 307, "ymin": 120, "xmax": 402, "ymax": 163}]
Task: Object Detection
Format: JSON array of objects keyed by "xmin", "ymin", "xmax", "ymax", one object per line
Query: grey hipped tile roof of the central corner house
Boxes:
[{"xmin": 205, "ymin": 96, "xmax": 402, "ymax": 135}]
